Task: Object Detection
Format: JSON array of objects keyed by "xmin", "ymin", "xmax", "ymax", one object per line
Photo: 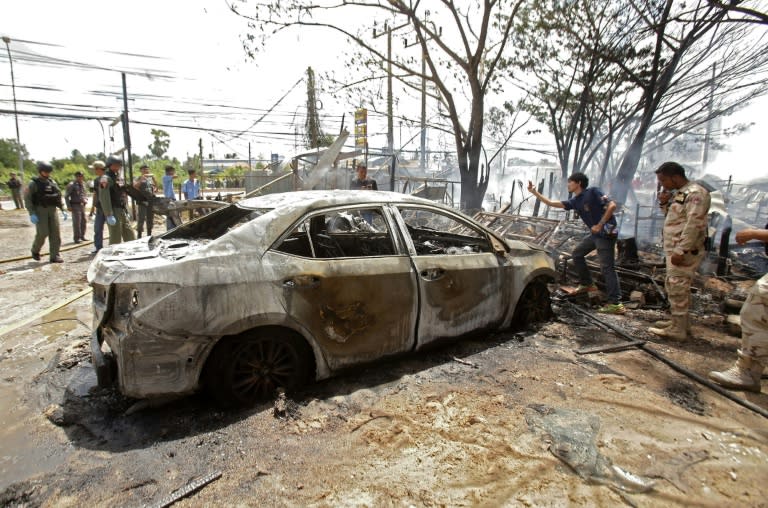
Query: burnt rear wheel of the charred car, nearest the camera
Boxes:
[{"xmin": 204, "ymin": 328, "xmax": 314, "ymax": 407}]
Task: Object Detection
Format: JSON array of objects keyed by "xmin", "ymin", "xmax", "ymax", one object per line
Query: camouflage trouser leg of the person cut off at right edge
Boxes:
[{"xmin": 739, "ymin": 274, "xmax": 768, "ymax": 365}]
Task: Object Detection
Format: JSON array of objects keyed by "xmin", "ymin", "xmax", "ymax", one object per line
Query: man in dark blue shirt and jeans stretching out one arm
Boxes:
[{"xmin": 528, "ymin": 173, "xmax": 626, "ymax": 314}]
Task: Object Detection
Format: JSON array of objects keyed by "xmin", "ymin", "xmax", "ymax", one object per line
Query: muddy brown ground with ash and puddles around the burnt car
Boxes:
[{"xmin": 0, "ymin": 207, "xmax": 768, "ymax": 507}]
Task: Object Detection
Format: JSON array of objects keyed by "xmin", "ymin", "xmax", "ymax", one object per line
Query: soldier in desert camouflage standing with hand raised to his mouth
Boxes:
[{"xmin": 648, "ymin": 162, "xmax": 710, "ymax": 340}]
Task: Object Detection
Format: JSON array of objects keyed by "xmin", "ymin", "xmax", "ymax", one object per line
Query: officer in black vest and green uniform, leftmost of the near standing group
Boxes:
[{"xmin": 24, "ymin": 161, "xmax": 64, "ymax": 263}]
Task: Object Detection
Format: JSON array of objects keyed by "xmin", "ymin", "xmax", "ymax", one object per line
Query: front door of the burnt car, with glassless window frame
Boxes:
[{"xmin": 390, "ymin": 205, "xmax": 510, "ymax": 348}]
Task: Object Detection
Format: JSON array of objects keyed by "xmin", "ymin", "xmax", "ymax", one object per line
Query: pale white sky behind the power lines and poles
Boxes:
[{"xmin": 0, "ymin": 0, "xmax": 768, "ymax": 181}]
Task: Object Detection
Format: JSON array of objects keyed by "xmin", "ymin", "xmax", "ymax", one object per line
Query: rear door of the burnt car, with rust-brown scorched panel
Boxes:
[{"xmin": 270, "ymin": 206, "xmax": 417, "ymax": 369}]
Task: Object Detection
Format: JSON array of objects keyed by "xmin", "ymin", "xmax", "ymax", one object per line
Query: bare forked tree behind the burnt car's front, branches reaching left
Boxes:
[{"xmin": 230, "ymin": 0, "xmax": 522, "ymax": 209}]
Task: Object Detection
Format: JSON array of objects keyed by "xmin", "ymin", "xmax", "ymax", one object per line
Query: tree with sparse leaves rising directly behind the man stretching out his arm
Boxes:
[{"xmin": 512, "ymin": 1, "xmax": 635, "ymax": 189}]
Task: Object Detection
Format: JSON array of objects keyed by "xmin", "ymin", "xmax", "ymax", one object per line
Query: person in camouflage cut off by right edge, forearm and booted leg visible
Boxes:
[{"xmin": 709, "ymin": 229, "xmax": 768, "ymax": 392}]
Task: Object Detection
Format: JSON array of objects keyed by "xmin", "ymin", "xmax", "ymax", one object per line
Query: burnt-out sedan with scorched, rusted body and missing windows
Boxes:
[{"xmin": 88, "ymin": 191, "xmax": 555, "ymax": 405}]
